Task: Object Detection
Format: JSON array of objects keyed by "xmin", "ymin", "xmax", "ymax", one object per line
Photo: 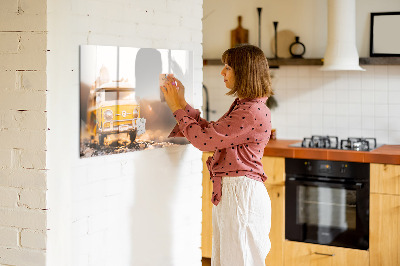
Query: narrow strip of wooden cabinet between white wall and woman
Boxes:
[{"xmin": 201, "ymin": 152, "xmax": 213, "ymax": 258}]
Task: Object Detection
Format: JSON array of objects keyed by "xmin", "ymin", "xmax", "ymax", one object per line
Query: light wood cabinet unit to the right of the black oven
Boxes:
[{"xmin": 369, "ymin": 164, "xmax": 400, "ymax": 266}]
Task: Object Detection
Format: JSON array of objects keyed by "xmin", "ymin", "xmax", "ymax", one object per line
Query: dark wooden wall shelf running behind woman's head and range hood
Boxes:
[{"xmin": 203, "ymin": 57, "xmax": 400, "ymax": 68}]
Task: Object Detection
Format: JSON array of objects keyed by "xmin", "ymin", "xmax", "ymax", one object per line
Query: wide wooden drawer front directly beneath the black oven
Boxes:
[{"xmin": 284, "ymin": 240, "xmax": 369, "ymax": 266}]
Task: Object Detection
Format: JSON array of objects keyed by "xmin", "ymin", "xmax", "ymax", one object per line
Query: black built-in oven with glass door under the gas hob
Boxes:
[{"xmin": 285, "ymin": 158, "xmax": 369, "ymax": 250}]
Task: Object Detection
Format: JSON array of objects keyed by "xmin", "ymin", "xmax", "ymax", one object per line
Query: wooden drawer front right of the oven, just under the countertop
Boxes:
[{"xmin": 370, "ymin": 163, "xmax": 400, "ymax": 195}]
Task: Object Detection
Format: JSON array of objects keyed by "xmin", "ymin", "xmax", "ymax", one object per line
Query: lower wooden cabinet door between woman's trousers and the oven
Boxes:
[{"xmin": 265, "ymin": 184, "xmax": 285, "ymax": 266}]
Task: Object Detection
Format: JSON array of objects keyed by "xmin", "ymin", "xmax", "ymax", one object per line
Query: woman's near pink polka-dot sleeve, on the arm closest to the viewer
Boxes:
[{"xmin": 174, "ymin": 105, "xmax": 256, "ymax": 151}]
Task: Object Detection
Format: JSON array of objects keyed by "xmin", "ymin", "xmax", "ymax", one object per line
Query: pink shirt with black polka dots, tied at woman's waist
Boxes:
[{"xmin": 169, "ymin": 97, "xmax": 271, "ymax": 205}]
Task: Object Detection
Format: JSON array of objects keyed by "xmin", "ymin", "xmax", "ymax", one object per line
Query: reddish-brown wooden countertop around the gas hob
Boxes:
[{"xmin": 264, "ymin": 140, "xmax": 400, "ymax": 164}]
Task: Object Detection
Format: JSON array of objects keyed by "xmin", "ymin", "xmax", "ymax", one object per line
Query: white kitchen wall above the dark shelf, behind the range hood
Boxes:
[{"xmin": 203, "ymin": 0, "xmax": 400, "ymax": 59}]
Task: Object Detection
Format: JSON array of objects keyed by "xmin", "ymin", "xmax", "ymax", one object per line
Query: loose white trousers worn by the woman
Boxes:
[{"xmin": 211, "ymin": 176, "xmax": 271, "ymax": 266}]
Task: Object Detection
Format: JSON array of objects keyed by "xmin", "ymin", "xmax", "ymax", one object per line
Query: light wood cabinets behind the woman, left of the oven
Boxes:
[{"xmin": 201, "ymin": 155, "xmax": 285, "ymax": 265}]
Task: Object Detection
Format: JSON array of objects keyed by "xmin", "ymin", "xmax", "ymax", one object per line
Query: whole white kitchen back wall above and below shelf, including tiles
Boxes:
[{"xmin": 203, "ymin": 0, "xmax": 400, "ymax": 144}]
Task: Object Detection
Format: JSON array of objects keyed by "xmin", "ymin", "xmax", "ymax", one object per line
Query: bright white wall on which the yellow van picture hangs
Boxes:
[{"xmin": 47, "ymin": 0, "xmax": 203, "ymax": 266}]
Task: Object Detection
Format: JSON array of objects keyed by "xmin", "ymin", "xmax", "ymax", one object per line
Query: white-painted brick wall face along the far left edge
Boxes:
[{"xmin": 0, "ymin": 0, "xmax": 47, "ymax": 265}]
